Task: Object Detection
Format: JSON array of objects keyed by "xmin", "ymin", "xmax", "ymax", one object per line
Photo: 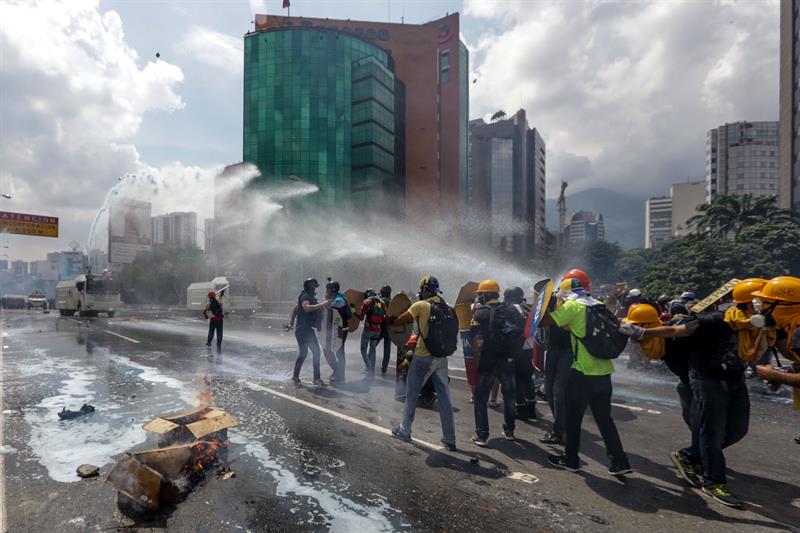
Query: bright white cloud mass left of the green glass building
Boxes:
[{"xmin": 0, "ymin": 1, "xmax": 184, "ymax": 258}]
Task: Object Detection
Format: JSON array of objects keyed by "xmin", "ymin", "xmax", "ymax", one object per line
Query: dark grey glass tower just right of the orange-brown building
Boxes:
[{"xmin": 467, "ymin": 109, "xmax": 545, "ymax": 259}]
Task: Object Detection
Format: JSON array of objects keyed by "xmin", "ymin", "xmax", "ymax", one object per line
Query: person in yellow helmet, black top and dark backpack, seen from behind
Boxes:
[{"xmin": 470, "ymin": 279, "xmax": 525, "ymax": 447}]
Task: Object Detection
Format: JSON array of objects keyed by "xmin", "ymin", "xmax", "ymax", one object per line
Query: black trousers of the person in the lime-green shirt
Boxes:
[{"xmin": 564, "ymin": 370, "xmax": 630, "ymax": 467}]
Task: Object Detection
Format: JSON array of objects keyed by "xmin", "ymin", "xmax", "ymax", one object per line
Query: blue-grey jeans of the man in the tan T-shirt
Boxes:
[{"xmin": 400, "ymin": 355, "xmax": 456, "ymax": 444}]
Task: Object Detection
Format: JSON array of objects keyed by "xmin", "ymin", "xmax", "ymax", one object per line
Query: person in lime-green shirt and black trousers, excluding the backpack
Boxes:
[{"xmin": 541, "ymin": 278, "xmax": 633, "ymax": 475}]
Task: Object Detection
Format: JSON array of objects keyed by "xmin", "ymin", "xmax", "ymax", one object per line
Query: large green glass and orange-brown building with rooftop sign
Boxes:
[{"xmin": 250, "ymin": 13, "xmax": 469, "ymax": 221}]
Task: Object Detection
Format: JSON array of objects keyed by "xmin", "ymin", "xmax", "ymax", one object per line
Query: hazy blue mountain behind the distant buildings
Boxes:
[{"xmin": 545, "ymin": 188, "xmax": 648, "ymax": 248}]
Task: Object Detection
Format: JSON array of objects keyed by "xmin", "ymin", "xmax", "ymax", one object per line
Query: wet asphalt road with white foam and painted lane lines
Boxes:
[{"xmin": 0, "ymin": 311, "xmax": 800, "ymax": 533}]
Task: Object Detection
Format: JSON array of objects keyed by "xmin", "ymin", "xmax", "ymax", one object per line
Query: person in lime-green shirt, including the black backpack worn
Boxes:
[{"xmin": 540, "ymin": 278, "xmax": 633, "ymax": 476}]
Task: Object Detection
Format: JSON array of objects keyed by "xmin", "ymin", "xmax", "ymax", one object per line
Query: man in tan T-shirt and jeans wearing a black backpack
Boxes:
[{"xmin": 390, "ymin": 276, "xmax": 458, "ymax": 451}]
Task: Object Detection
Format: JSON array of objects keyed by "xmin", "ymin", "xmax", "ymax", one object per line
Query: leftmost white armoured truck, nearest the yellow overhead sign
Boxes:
[{"xmin": 56, "ymin": 274, "xmax": 122, "ymax": 318}]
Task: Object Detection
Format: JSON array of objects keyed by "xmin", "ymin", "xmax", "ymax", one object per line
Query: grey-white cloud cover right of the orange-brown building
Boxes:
[{"xmin": 465, "ymin": 0, "xmax": 779, "ymax": 195}]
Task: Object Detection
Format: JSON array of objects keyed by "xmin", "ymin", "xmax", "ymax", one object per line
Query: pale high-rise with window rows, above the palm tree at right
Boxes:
[{"xmin": 706, "ymin": 121, "xmax": 778, "ymax": 200}]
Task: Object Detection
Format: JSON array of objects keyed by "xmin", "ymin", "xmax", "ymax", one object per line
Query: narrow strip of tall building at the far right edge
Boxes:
[{"xmin": 778, "ymin": 0, "xmax": 800, "ymax": 209}]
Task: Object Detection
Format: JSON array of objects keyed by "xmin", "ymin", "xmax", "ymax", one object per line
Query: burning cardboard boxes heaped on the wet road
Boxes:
[{"xmin": 106, "ymin": 406, "xmax": 238, "ymax": 516}]
